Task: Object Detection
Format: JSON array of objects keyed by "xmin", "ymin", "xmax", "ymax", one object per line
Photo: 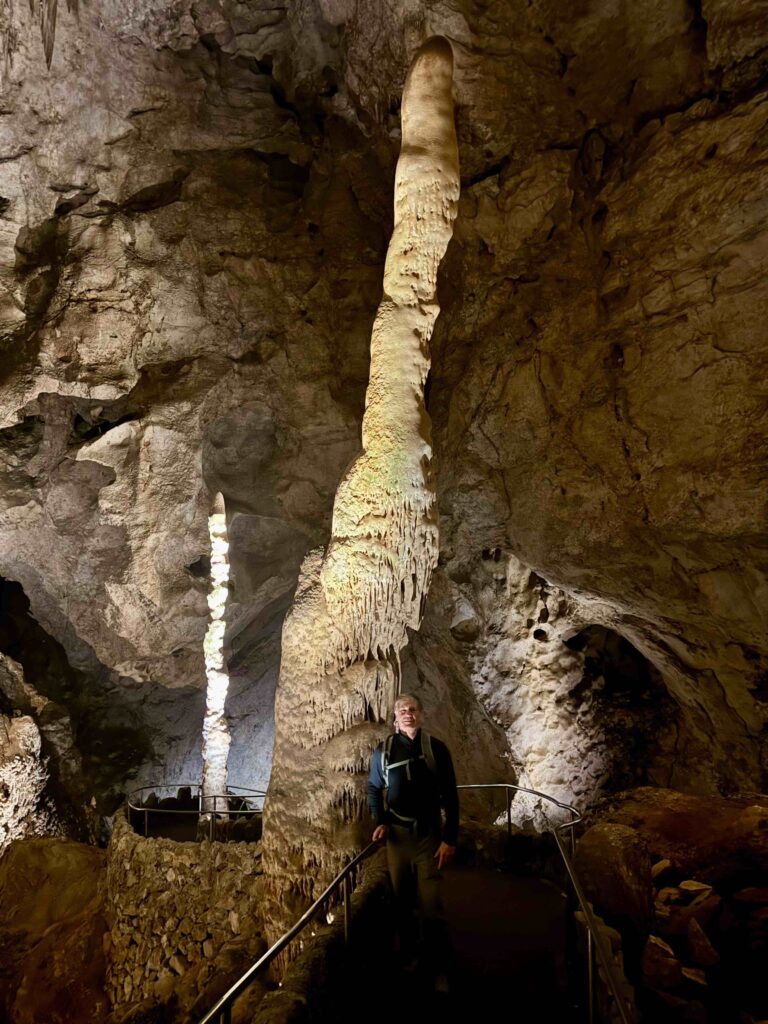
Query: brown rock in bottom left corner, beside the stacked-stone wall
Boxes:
[{"xmin": 0, "ymin": 839, "xmax": 109, "ymax": 1024}]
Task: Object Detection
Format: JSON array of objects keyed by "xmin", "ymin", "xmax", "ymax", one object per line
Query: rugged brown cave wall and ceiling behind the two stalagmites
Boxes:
[{"xmin": 0, "ymin": 0, "xmax": 768, "ymax": 788}]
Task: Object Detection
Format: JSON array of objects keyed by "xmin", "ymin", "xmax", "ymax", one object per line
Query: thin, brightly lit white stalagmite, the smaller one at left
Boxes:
[{"xmin": 201, "ymin": 494, "xmax": 229, "ymax": 813}]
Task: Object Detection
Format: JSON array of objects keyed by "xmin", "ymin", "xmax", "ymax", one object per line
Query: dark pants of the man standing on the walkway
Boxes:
[{"xmin": 387, "ymin": 824, "xmax": 449, "ymax": 972}]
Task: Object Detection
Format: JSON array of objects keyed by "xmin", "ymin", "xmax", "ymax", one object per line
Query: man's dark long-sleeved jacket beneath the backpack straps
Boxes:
[{"xmin": 368, "ymin": 729, "xmax": 459, "ymax": 846}]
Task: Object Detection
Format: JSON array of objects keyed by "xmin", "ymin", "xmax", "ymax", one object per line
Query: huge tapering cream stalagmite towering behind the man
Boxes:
[{"xmin": 264, "ymin": 37, "xmax": 459, "ymax": 936}]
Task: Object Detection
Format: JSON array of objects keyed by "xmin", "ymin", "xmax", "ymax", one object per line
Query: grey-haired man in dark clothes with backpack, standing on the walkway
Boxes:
[{"xmin": 368, "ymin": 693, "xmax": 459, "ymax": 973}]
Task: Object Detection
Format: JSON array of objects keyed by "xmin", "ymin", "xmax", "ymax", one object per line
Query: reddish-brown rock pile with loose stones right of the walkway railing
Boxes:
[{"xmin": 577, "ymin": 787, "xmax": 768, "ymax": 1024}]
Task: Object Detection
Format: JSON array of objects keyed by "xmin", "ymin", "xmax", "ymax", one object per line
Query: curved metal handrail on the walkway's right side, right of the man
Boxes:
[{"xmin": 457, "ymin": 782, "xmax": 633, "ymax": 1024}]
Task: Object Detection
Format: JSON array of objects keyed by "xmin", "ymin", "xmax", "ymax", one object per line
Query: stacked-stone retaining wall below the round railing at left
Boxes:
[{"xmin": 105, "ymin": 813, "xmax": 263, "ymax": 1014}]
